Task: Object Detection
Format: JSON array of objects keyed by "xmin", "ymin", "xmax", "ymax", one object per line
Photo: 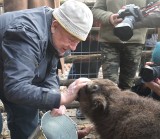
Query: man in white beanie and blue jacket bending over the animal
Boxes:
[{"xmin": 0, "ymin": 0, "xmax": 93, "ymax": 139}]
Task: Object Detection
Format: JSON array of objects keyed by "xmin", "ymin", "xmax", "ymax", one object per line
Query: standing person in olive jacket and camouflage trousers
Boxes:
[{"xmin": 92, "ymin": 0, "xmax": 158, "ymax": 90}]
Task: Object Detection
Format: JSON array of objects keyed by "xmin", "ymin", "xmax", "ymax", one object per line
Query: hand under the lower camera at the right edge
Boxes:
[{"xmin": 144, "ymin": 78, "xmax": 160, "ymax": 96}]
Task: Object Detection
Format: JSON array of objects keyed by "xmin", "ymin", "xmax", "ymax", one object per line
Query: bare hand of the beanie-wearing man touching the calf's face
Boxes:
[{"xmin": 60, "ymin": 78, "xmax": 90, "ymax": 105}]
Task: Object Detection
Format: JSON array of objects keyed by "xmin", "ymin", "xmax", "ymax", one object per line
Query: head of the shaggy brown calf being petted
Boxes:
[{"xmin": 79, "ymin": 79, "xmax": 120, "ymax": 118}]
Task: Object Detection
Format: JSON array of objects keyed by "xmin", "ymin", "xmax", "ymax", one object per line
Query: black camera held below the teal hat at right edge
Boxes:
[{"xmin": 140, "ymin": 65, "xmax": 160, "ymax": 82}]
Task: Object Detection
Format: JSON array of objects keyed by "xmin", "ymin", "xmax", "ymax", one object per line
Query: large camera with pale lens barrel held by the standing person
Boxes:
[{"xmin": 113, "ymin": 4, "xmax": 142, "ymax": 41}]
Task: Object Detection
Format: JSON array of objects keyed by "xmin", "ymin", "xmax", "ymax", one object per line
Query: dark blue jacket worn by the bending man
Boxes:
[{"xmin": 0, "ymin": 7, "xmax": 60, "ymax": 110}]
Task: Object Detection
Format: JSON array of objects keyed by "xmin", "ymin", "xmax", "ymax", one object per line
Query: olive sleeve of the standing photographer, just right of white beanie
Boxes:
[{"xmin": 92, "ymin": 0, "xmax": 113, "ymax": 25}]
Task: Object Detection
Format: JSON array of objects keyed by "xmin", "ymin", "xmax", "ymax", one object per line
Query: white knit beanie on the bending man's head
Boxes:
[{"xmin": 53, "ymin": 0, "xmax": 93, "ymax": 41}]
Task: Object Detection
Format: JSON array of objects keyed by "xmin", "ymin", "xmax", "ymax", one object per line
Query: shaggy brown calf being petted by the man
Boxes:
[{"xmin": 79, "ymin": 79, "xmax": 160, "ymax": 139}]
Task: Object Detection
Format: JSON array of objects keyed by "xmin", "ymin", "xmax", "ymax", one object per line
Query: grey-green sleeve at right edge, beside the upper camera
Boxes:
[{"xmin": 134, "ymin": 11, "xmax": 160, "ymax": 29}]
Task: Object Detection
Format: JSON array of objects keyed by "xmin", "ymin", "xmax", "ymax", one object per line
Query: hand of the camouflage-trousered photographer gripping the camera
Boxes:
[{"xmin": 109, "ymin": 14, "xmax": 123, "ymax": 26}]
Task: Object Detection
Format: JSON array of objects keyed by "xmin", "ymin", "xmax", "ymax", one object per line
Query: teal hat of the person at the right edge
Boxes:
[{"xmin": 152, "ymin": 42, "xmax": 160, "ymax": 65}]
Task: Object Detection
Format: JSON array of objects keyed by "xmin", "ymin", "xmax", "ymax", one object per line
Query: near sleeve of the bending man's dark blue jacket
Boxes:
[{"xmin": 2, "ymin": 25, "xmax": 60, "ymax": 110}]
